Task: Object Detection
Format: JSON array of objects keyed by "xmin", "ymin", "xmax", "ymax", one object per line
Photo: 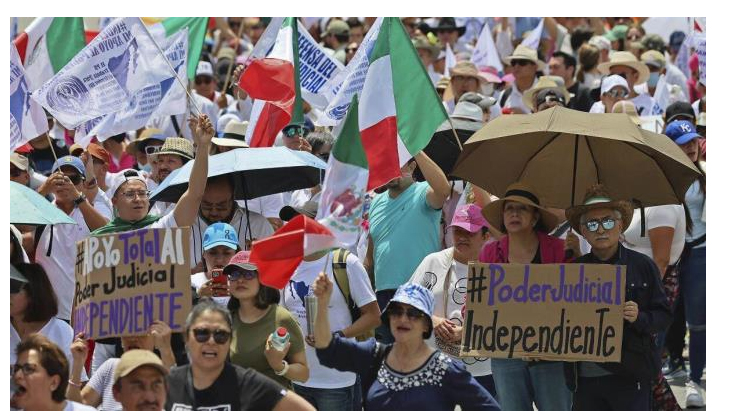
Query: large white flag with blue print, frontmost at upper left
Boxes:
[{"xmin": 32, "ymin": 17, "xmax": 172, "ymax": 128}]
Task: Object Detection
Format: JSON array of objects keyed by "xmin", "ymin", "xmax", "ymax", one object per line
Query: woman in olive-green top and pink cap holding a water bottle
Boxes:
[{"xmin": 223, "ymin": 251, "xmax": 310, "ymax": 389}]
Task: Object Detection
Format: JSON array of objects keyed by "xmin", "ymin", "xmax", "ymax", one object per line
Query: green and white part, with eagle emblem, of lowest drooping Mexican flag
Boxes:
[{"xmin": 317, "ymin": 96, "xmax": 369, "ymax": 248}]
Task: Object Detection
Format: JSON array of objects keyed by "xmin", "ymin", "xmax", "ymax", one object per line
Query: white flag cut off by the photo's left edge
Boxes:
[{"xmin": 10, "ymin": 42, "xmax": 49, "ymax": 153}]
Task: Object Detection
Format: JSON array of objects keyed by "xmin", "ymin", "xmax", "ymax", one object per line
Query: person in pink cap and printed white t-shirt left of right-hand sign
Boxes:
[{"xmin": 409, "ymin": 204, "xmax": 497, "ymax": 396}]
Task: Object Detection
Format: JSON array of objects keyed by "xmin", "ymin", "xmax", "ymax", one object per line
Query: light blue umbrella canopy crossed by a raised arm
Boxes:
[{"xmin": 151, "ymin": 147, "xmax": 326, "ymax": 203}]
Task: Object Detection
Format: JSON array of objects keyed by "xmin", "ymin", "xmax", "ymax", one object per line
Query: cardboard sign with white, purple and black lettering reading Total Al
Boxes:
[{"xmin": 72, "ymin": 228, "xmax": 192, "ymax": 339}]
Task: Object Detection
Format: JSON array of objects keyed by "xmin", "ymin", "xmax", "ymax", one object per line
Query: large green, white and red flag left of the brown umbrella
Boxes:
[{"xmin": 356, "ymin": 17, "xmax": 447, "ymax": 190}]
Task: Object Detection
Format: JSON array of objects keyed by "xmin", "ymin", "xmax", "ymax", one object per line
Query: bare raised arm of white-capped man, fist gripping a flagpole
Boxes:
[{"xmin": 174, "ymin": 114, "xmax": 215, "ymax": 226}]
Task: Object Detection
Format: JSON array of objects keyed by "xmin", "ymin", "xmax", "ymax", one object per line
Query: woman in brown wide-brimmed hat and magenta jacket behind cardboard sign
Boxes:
[{"xmin": 479, "ymin": 183, "xmax": 571, "ymax": 411}]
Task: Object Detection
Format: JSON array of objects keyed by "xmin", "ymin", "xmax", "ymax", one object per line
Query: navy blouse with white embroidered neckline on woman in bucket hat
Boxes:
[{"xmin": 316, "ymin": 336, "xmax": 500, "ymax": 411}]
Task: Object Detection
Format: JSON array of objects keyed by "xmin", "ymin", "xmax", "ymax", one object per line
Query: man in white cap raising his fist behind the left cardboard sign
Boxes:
[{"xmin": 92, "ymin": 114, "xmax": 215, "ymax": 235}]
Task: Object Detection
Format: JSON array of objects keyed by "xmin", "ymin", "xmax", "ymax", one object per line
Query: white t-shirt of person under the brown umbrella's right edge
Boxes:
[{"xmin": 623, "ymin": 204, "xmax": 687, "ymax": 265}]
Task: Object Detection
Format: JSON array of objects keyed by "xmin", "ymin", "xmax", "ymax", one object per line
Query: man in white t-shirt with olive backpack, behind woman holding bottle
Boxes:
[{"xmin": 281, "ymin": 209, "xmax": 380, "ymax": 411}]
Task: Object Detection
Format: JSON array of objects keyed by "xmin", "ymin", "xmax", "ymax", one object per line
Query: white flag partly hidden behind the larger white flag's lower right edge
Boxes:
[{"xmin": 74, "ymin": 28, "xmax": 189, "ymax": 146}]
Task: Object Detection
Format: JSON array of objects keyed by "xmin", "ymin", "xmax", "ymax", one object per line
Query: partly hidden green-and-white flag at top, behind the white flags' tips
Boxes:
[{"xmin": 141, "ymin": 17, "xmax": 209, "ymax": 79}]
